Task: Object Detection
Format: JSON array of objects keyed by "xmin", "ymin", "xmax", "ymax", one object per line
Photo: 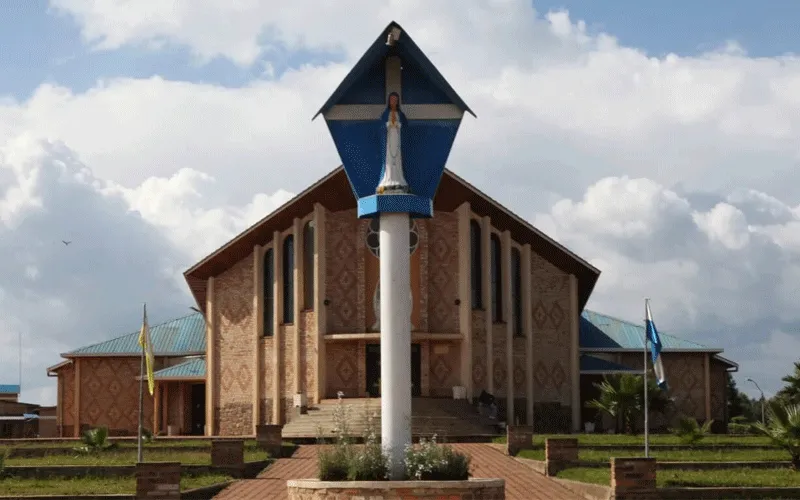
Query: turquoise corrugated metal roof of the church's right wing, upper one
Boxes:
[{"xmin": 580, "ymin": 310, "xmax": 722, "ymax": 352}]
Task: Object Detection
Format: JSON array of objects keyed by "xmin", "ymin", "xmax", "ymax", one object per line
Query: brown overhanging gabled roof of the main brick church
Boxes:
[{"xmin": 184, "ymin": 167, "xmax": 600, "ymax": 311}]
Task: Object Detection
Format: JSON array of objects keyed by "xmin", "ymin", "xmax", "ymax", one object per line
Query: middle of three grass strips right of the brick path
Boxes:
[{"xmin": 518, "ymin": 448, "xmax": 789, "ymax": 462}]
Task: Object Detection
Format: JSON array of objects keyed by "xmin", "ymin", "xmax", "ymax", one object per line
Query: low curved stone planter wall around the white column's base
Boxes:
[{"xmin": 286, "ymin": 479, "xmax": 506, "ymax": 500}]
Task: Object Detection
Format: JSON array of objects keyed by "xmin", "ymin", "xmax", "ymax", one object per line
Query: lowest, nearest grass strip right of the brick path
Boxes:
[{"xmin": 558, "ymin": 467, "xmax": 800, "ymax": 487}]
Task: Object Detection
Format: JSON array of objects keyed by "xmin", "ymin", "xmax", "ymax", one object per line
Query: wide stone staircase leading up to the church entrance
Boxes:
[{"xmin": 283, "ymin": 398, "xmax": 500, "ymax": 442}]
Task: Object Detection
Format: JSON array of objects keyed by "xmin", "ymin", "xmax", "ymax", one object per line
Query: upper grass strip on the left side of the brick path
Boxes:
[{"xmin": 6, "ymin": 448, "xmax": 269, "ymax": 466}]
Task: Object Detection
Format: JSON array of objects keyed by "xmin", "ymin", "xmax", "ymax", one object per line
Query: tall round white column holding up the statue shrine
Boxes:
[{"xmin": 380, "ymin": 213, "xmax": 411, "ymax": 480}]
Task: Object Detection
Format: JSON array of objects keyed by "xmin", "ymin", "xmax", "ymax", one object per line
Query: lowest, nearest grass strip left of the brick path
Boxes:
[{"xmin": 0, "ymin": 474, "xmax": 231, "ymax": 496}]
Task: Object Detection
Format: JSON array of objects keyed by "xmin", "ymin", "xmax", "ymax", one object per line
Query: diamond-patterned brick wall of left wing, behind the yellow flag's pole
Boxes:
[{"xmin": 80, "ymin": 357, "xmax": 153, "ymax": 435}]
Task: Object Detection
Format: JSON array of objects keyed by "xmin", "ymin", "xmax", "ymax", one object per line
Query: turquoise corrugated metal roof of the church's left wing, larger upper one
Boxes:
[{"xmin": 64, "ymin": 313, "xmax": 206, "ymax": 356}]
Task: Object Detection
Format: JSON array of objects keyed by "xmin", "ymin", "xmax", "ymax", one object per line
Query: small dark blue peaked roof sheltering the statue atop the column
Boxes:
[{"xmin": 312, "ymin": 21, "xmax": 477, "ymax": 120}]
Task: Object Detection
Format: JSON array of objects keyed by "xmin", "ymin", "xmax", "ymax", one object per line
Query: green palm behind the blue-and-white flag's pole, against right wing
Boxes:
[{"xmin": 587, "ymin": 373, "xmax": 670, "ymax": 434}]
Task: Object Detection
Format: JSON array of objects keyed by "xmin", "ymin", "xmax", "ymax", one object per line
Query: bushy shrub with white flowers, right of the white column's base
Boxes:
[{"xmin": 405, "ymin": 436, "xmax": 470, "ymax": 481}]
